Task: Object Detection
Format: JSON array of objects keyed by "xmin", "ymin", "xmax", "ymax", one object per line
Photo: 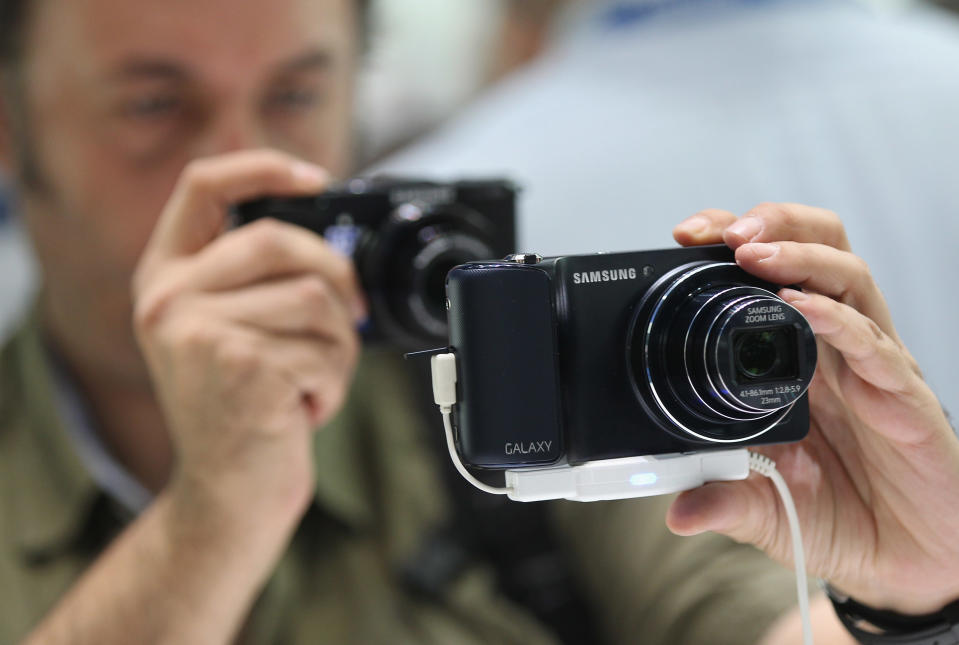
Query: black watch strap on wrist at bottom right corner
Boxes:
[{"xmin": 826, "ymin": 585, "xmax": 959, "ymax": 645}]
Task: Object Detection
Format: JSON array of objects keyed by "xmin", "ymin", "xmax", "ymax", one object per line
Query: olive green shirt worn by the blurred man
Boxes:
[{"xmin": 0, "ymin": 324, "xmax": 795, "ymax": 645}]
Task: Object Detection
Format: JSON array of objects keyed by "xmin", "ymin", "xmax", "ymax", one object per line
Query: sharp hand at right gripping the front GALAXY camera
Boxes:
[{"xmin": 667, "ymin": 204, "xmax": 959, "ymax": 614}]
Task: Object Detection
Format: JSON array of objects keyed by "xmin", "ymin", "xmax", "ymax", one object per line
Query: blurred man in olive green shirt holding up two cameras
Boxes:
[{"xmin": 0, "ymin": 0, "xmax": 959, "ymax": 644}]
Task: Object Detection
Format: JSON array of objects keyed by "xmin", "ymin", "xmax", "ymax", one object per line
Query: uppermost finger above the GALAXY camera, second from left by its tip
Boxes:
[{"xmin": 723, "ymin": 203, "xmax": 850, "ymax": 251}]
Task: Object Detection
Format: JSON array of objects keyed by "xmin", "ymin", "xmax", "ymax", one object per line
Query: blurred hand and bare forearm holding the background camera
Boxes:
[{"xmin": 27, "ymin": 151, "xmax": 365, "ymax": 645}]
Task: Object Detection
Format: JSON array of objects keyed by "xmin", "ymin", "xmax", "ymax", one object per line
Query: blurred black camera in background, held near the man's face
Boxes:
[{"xmin": 234, "ymin": 177, "xmax": 517, "ymax": 349}]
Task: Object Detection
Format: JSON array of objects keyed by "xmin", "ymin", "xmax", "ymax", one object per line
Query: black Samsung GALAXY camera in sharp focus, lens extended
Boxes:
[{"xmin": 446, "ymin": 246, "xmax": 816, "ymax": 469}]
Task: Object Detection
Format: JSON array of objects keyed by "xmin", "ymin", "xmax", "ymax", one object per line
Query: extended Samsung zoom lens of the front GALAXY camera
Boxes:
[{"xmin": 628, "ymin": 262, "xmax": 816, "ymax": 442}]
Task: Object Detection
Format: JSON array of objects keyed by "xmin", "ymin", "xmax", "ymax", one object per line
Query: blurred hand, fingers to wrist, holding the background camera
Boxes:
[{"xmin": 133, "ymin": 151, "xmax": 364, "ymax": 534}]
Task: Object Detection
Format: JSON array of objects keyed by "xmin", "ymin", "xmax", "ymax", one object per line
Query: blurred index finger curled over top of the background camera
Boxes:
[{"xmin": 147, "ymin": 150, "xmax": 329, "ymax": 258}]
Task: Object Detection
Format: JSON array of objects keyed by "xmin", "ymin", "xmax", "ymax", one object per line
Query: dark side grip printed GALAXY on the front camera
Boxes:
[{"xmin": 447, "ymin": 264, "xmax": 564, "ymax": 468}]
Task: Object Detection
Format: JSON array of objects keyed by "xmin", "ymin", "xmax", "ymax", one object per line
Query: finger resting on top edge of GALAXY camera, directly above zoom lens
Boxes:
[{"xmin": 736, "ymin": 242, "xmax": 899, "ymax": 334}]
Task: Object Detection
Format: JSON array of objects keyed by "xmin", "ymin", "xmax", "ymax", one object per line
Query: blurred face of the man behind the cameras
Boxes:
[{"xmin": 0, "ymin": 0, "xmax": 356, "ymax": 372}]
